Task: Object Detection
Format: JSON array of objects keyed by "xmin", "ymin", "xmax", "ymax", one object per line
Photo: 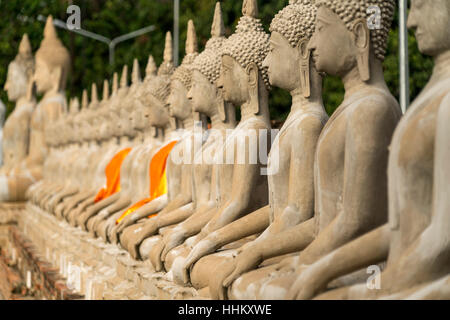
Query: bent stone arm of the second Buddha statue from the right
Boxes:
[{"xmin": 292, "ymin": 102, "xmax": 396, "ymax": 265}]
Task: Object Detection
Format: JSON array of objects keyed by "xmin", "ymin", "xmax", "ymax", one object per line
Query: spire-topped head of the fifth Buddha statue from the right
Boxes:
[{"xmin": 188, "ymin": 2, "xmax": 232, "ymax": 121}]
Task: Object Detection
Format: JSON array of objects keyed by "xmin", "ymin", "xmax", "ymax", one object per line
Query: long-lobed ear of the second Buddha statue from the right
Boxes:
[{"xmin": 353, "ymin": 19, "xmax": 370, "ymax": 81}]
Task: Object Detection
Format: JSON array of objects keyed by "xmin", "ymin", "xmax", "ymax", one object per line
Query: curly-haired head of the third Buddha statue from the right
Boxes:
[{"xmin": 263, "ymin": 0, "xmax": 321, "ymax": 98}]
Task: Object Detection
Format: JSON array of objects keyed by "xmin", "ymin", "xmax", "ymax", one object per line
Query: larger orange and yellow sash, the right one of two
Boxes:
[{"xmin": 116, "ymin": 141, "xmax": 178, "ymax": 224}]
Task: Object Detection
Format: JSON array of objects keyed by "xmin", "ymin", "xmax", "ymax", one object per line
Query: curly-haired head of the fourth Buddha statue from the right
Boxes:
[{"xmin": 219, "ymin": 0, "xmax": 270, "ymax": 114}]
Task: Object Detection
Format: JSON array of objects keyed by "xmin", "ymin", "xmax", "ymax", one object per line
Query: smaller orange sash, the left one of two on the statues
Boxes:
[{"xmin": 95, "ymin": 148, "xmax": 131, "ymax": 203}]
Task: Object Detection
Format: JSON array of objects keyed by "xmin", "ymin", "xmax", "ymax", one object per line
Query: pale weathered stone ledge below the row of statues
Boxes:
[{"xmin": 18, "ymin": 203, "xmax": 198, "ymax": 300}]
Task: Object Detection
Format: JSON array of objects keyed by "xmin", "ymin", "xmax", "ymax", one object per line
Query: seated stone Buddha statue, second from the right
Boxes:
[{"xmin": 220, "ymin": 0, "xmax": 401, "ymax": 299}]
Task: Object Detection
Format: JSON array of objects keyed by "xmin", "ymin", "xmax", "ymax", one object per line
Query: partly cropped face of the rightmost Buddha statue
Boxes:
[{"xmin": 408, "ymin": 0, "xmax": 450, "ymax": 56}]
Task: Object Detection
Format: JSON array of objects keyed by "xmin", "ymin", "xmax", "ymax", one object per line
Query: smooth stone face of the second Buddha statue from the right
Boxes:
[{"xmin": 308, "ymin": 6, "xmax": 357, "ymax": 77}]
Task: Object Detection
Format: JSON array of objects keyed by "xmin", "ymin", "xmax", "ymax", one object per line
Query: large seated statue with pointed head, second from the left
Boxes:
[{"xmin": 0, "ymin": 16, "xmax": 70, "ymax": 201}]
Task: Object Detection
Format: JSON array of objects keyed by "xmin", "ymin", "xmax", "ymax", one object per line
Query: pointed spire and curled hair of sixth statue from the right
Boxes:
[{"xmin": 172, "ymin": 20, "xmax": 198, "ymax": 90}]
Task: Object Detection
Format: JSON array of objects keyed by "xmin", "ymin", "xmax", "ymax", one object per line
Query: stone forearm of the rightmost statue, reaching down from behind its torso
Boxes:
[{"xmin": 286, "ymin": 224, "xmax": 391, "ymax": 300}]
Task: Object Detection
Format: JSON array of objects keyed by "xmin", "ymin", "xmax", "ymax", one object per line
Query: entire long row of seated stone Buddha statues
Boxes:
[{"xmin": 0, "ymin": 0, "xmax": 450, "ymax": 299}]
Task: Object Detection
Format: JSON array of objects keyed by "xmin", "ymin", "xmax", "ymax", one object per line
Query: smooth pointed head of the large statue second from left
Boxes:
[{"xmin": 34, "ymin": 16, "xmax": 70, "ymax": 93}]
